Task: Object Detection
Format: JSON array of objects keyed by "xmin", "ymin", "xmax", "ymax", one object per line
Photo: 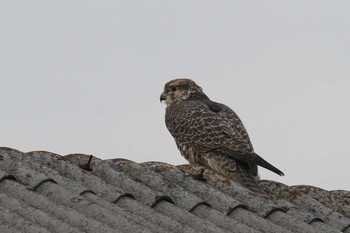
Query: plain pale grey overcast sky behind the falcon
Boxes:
[{"xmin": 0, "ymin": 0, "xmax": 350, "ymax": 190}]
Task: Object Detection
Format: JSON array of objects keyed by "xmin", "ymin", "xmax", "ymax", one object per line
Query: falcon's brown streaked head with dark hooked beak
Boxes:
[{"xmin": 160, "ymin": 78, "xmax": 206, "ymax": 106}]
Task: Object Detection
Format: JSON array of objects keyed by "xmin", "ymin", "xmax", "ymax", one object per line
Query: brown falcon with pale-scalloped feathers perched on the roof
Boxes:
[{"xmin": 160, "ymin": 79, "xmax": 284, "ymax": 193}]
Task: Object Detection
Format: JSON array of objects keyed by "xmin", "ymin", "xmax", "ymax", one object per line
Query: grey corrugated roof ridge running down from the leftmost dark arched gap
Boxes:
[{"xmin": 0, "ymin": 179, "xmax": 115, "ymax": 232}]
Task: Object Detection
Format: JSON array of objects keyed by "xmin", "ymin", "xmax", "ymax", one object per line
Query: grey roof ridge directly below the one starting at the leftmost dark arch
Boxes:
[{"xmin": 0, "ymin": 193, "xmax": 81, "ymax": 233}]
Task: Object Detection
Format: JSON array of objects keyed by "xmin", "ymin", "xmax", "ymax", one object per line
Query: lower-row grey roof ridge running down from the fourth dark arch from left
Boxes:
[{"xmin": 115, "ymin": 196, "xmax": 196, "ymax": 233}]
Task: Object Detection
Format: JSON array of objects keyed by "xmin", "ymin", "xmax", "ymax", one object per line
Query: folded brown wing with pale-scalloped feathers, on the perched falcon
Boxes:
[{"xmin": 166, "ymin": 100, "xmax": 283, "ymax": 174}]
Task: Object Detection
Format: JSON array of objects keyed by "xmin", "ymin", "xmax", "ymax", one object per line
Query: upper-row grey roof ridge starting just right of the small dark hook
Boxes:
[{"xmin": 107, "ymin": 159, "xmax": 209, "ymax": 211}]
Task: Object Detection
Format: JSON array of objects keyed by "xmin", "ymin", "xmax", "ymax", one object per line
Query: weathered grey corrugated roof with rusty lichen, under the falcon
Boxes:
[{"xmin": 0, "ymin": 148, "xmax": 350, "ymax": 233}]
